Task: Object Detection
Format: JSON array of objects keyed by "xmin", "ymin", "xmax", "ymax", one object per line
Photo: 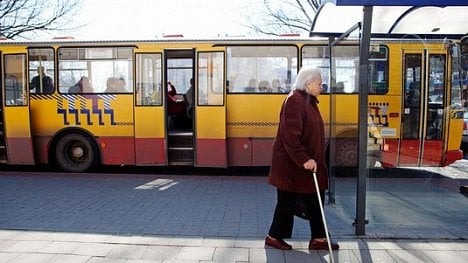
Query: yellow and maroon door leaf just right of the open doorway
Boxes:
[{"xmin": 194, "ymin": 48, "xmax": 227, "ymax": 167}]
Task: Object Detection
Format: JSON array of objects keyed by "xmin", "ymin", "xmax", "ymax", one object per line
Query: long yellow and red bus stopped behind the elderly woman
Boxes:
[{"xmin": 0, "ymin": 37, "xmax": 463, "ymax": 172}]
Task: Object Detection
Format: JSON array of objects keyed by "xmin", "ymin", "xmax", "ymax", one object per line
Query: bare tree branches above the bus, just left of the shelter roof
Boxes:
[{"xmin": 246, "ymin": 0, "xmax": 322, "ymax": 35}]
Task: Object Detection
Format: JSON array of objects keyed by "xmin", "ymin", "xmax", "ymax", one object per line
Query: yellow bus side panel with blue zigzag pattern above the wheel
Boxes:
[{"xmin": 30, "ymin": 94, "xmax": 133, "ymax": 136}]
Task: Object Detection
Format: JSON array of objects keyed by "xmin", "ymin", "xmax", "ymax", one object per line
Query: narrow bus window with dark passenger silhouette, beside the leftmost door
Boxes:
[{"xmin": 28, "ymin": 48, "xmax": 55, "ymax": 93}]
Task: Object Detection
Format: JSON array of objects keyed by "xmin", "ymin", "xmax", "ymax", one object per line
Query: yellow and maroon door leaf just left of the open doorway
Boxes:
[{"xmin": 134, "ymin": 51, "xmax": 167, "ymax": 165}]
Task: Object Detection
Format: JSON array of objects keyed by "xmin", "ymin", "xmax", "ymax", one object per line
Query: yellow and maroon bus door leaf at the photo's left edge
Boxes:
[{"xmin": 0, "ymin": 54, "xmax": 34, "ymax": 164}]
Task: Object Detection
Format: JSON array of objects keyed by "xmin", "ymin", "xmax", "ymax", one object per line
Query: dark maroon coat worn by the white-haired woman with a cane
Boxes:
[{"xmin": 268, "ymin": 90, "xmax": 328, "ymax": 193}]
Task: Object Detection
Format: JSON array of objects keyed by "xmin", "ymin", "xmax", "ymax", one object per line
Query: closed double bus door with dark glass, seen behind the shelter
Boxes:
[{"xmin": 399, "ymin": 50, "xmax": 448, "ymax": 166}]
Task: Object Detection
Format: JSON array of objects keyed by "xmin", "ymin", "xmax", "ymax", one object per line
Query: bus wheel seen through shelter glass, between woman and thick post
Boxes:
[{"xmin": 335, "ymin": 140, "xmax": 358, "ymax": 177}]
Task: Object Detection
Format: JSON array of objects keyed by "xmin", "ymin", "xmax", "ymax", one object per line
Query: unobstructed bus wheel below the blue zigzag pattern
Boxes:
[{"xmin": 55, "ymin": 133, "xmax": 97, "ymax": 173}]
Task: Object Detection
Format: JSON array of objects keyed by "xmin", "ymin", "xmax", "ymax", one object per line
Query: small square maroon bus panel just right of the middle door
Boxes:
[{"xmin": 227, "ymin": 138, "xmax": 252, "ymax": 166}]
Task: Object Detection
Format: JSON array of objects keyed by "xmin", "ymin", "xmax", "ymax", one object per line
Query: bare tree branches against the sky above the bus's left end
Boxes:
[{"xmin": 0, "ymin": 0, "xmax": 82, "ymax": 39}]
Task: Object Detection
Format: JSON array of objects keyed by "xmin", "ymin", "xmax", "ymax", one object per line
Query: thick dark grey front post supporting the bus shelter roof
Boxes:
[{"xmin": 355, "ymin": 6, "xmax": 372, "ymax": 235}]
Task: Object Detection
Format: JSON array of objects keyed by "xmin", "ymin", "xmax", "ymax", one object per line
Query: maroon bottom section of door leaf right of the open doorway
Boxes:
[{"xmin": 196, "ymin": 138, "xmax": 227, "ymax": 167}]
